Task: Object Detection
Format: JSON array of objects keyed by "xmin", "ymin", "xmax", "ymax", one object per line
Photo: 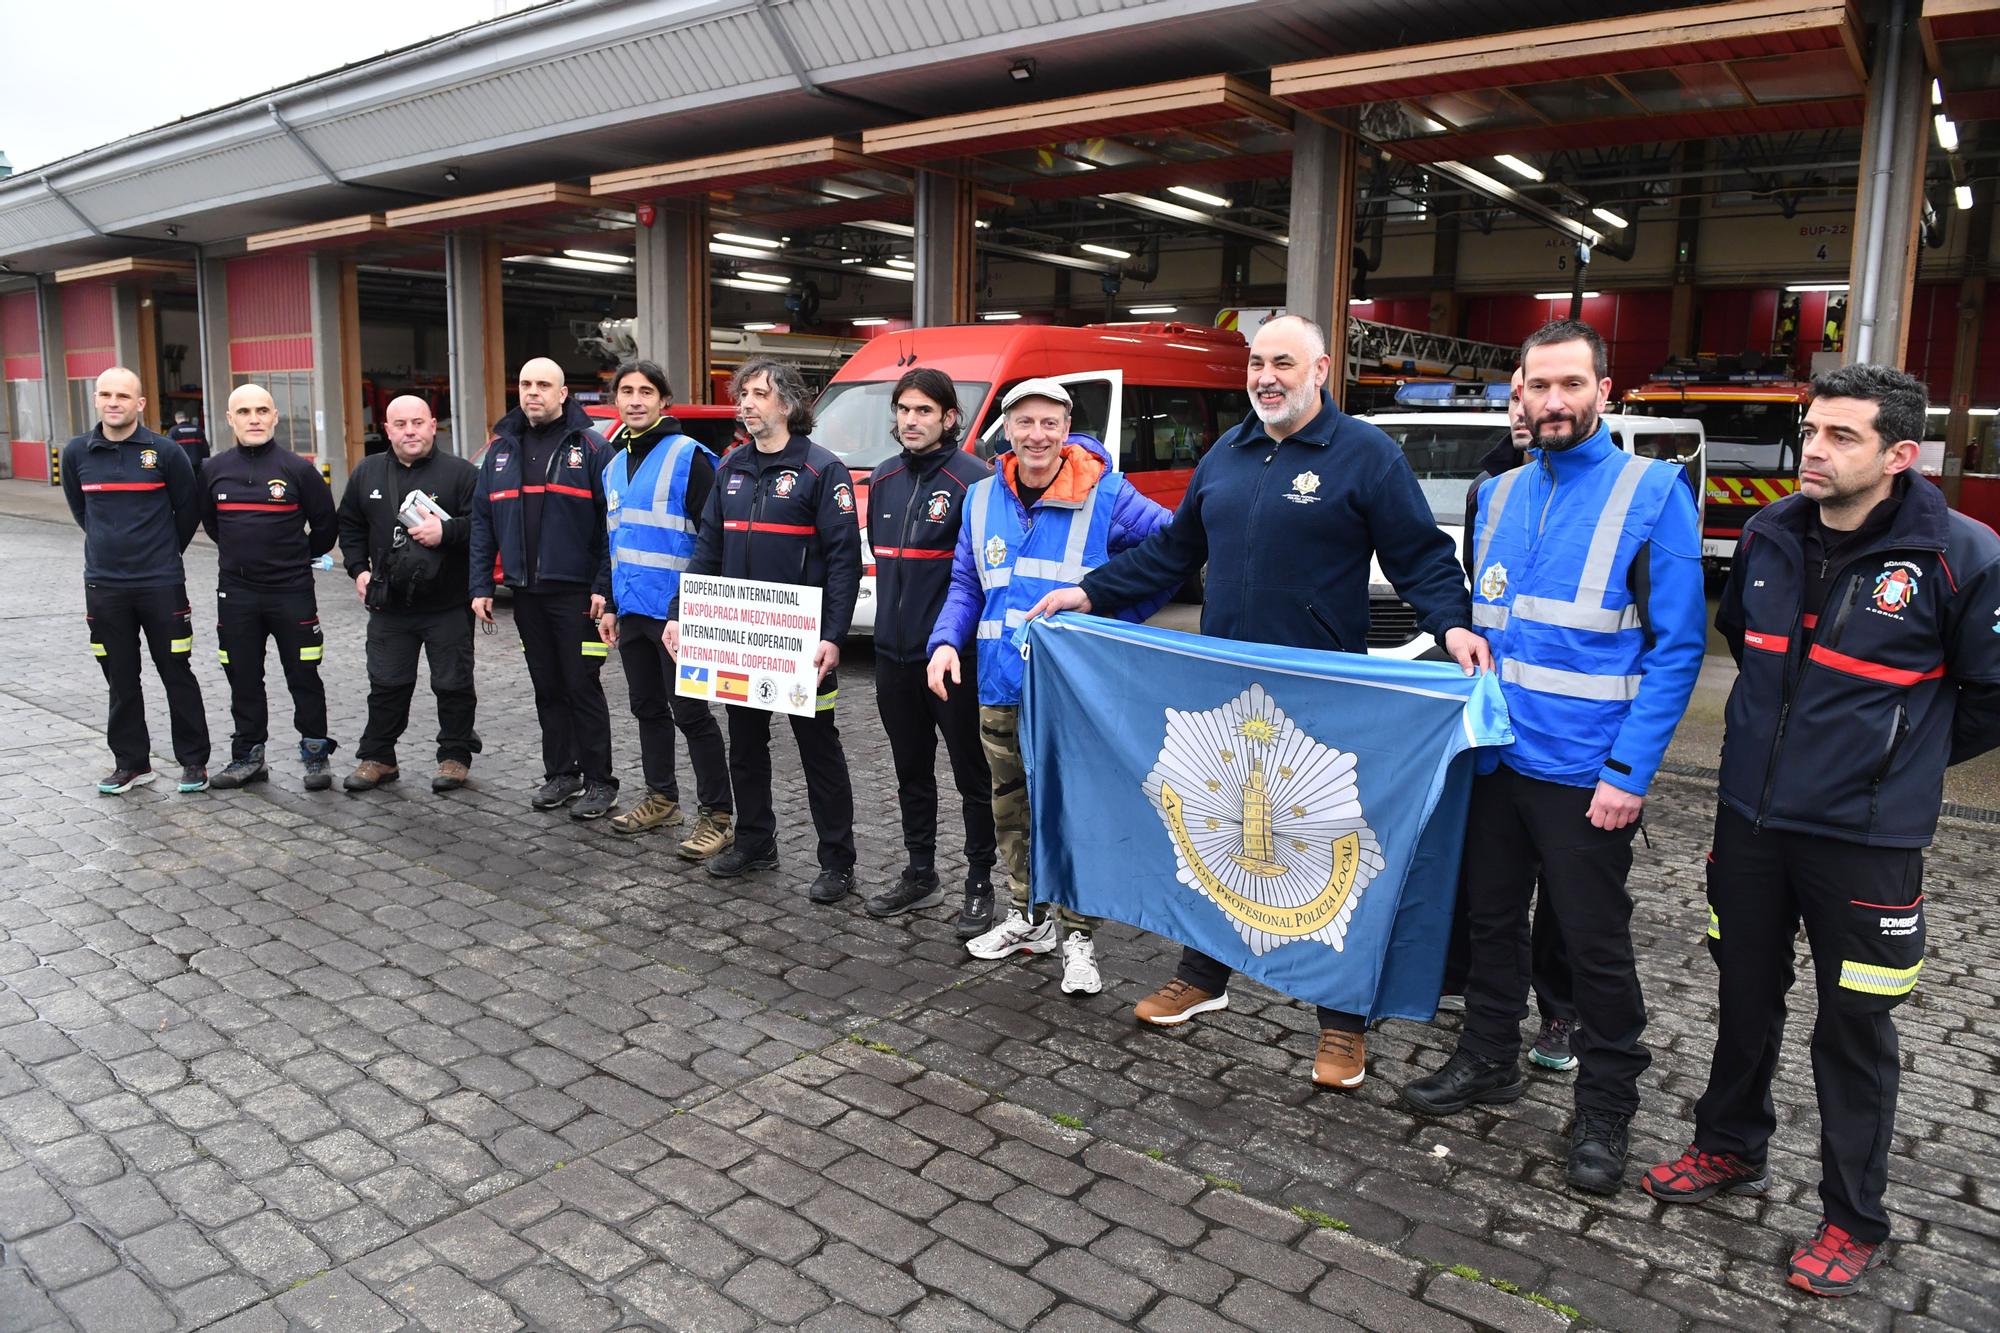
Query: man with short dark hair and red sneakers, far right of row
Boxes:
[{"xmin": 1642, "ymin": 364, "xmax": 2000, "ymax": 1297}]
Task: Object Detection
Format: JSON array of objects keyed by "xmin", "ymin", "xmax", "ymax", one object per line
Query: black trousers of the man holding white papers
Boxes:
[{"xmin": 354, "ymin": 606, "xmax": 480, "ymax": 767}]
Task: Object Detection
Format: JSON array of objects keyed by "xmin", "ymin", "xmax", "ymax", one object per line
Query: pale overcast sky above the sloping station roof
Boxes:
[{"xmin": 0, "ymin": 0, "xmax": 500, "ymax": 172}]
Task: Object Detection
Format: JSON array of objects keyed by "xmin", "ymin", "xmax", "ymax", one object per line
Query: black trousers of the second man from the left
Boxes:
[{"xmin": 216, "ymin": 586, "xmax": 326, "ymax": 761}]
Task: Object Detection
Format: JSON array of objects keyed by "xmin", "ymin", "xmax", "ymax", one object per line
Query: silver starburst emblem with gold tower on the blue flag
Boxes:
[{"xmin": 1146, "ymin": 685, "xmax": 1384, "ymax": 957}]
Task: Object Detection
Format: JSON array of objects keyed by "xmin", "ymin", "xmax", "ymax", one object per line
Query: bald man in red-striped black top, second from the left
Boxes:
[{"xmin": 202, "ymin": 384, "xmax": 336, "ymax": 791}]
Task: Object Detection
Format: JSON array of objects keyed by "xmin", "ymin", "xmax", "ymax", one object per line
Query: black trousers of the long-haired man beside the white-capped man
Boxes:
[{"xmin": 876, "ymin": 656, "xmax": 996, "ymax": 873}]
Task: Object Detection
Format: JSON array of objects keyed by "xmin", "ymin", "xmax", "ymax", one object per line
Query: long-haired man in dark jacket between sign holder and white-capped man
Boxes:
[{"xmin": 868, "ymin": 366, "xmax": 996, "ymax": 924}]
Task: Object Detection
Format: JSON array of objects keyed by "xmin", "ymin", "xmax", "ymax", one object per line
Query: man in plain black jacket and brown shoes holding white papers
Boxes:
[{"xmin": 340, "ymin": 394, "xmax": 480, "ymax": 793}]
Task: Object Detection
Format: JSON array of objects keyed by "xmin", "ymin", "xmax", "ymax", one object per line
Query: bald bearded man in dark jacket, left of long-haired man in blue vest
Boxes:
[{"xmin": 470, "ymin": 356, "xmax": 618, "ymax": 819}]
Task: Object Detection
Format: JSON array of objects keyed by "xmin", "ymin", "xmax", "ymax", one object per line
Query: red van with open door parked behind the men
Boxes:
[{"xmin": 812, "ymin": 324, "xmax": 1250, "ymax": 634}]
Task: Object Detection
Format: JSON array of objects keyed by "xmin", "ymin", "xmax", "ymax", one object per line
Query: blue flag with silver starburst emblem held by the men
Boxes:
[{"xmin": 1020, "ymin": 614, "xmax": 1514, "ymax": 1021}]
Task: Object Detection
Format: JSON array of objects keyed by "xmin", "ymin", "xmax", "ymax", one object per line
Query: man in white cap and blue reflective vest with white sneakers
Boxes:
[{"xmin": 928, "ymin": 378, "xmax": 1170, "ymax": 995}]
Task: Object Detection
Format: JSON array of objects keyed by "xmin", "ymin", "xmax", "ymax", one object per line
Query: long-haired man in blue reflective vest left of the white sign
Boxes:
[{"xmin": 598, "ymin": 360, "xmax": 736, "ymax": 861}]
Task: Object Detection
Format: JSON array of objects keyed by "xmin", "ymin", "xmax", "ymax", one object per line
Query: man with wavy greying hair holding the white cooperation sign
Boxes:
[{"xmin": 666, "ymin": 356, "xmax": 862, "ymax": 905}]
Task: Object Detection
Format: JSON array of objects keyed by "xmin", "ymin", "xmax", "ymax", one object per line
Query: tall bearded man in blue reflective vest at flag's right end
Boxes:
[{"xmin": 1402, "ymin": 320, "xmax": 1706, "ymax": 1195}]
